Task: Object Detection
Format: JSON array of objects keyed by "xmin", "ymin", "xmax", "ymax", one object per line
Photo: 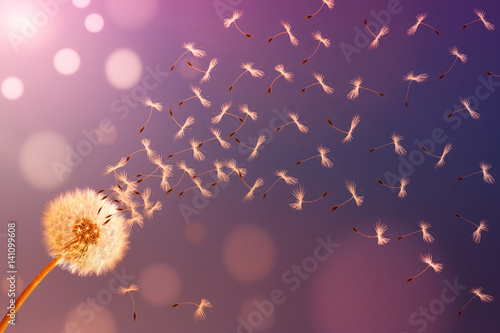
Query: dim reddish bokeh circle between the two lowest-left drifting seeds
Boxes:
[{"xmin": 138, "ymin": 263, "xmax": 182, "ymax": 307}]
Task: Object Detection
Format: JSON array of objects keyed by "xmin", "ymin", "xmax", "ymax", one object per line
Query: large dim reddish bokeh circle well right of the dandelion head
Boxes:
[{"xmin": 222, "ymin": 225, "xmax": 276, "ymax": 283}]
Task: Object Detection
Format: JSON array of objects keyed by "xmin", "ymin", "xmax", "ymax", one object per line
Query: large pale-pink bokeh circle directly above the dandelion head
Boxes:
[{"xmin": 19, "ymin": 131, "xmax": 70, "ymax": 190}]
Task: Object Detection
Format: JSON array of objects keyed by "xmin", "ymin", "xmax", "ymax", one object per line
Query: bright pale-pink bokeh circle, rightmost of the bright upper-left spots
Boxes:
[{"xmin": 105, "ymin": 49, "xmax": 142, "ymax": 90}]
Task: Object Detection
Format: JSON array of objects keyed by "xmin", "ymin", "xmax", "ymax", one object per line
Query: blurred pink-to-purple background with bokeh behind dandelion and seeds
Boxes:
[{"xmin": 0, "ymin": 0, "xmax": 500, "ymax": 333}]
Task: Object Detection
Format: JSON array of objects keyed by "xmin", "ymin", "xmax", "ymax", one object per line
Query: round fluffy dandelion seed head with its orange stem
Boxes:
[{"xmin": 0, "ymin": 188, "xmax": 129, "ymax": 332}]
